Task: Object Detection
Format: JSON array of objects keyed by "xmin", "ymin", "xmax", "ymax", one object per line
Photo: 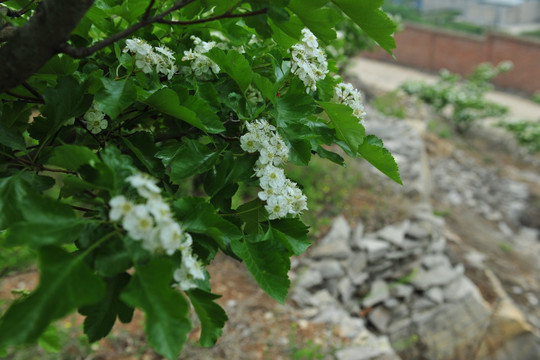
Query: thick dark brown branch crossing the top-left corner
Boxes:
[{"xmin": 0, "ymin": 0, "xmax": 94, "ymax": 93}]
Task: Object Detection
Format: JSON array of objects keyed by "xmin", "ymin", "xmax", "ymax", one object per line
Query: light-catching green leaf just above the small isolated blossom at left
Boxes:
[{"xmin": 96, "ymin": 78, "xmax": 137, "ymax": 119}]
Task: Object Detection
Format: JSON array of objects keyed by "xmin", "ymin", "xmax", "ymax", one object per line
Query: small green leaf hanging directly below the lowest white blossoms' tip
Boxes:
[{"xmin": 187, "ymin": 289, "xmax": 228, "ymax": 347}]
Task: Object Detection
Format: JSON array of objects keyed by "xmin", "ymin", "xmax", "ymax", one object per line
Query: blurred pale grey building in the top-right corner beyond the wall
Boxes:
[{"xmin": 414, "ymin": 0, "xmax": 540, "ymax": 27}]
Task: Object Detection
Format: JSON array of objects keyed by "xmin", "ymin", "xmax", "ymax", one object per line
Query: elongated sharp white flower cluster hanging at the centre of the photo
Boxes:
[{"xmin": 240, "ymin": 120, "xmax": 307, "ymax": 220}]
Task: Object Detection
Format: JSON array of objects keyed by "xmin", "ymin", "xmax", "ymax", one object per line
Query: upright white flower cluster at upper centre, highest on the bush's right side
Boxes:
[{"xmin": 291, "ymin": 29, "xmax": 328, "ymax": 92}]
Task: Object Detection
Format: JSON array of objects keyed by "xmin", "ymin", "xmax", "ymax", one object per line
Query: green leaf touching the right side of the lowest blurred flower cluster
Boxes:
[{"xmin": 173, "ymin": 197, "xmax": 242, "ymax": 249}]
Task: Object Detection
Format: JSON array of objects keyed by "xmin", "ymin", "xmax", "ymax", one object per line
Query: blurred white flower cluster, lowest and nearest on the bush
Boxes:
[{"xmin": 109, "ymin": 173, "xmax": 205, "ymax": 291}]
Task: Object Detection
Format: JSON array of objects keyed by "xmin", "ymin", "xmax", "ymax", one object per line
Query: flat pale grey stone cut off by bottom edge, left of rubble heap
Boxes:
[{"xmin": 335, "ymin": 336, "xmax": 400, "ymax": 360}]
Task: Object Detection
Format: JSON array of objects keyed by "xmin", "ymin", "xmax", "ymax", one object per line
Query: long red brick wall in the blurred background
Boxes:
[{"xmin": 362, "ymin": 24, "xmax": 540, "ymax": 94}]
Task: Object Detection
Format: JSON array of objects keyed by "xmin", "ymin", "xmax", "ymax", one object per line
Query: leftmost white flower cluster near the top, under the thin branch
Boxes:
[{"xmin": 124, "ymin": 38, "xmax": 178, "ymax": 80}]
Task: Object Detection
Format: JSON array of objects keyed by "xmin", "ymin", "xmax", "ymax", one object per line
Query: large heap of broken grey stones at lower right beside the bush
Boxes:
[{"xmin": 291, "ymin": 211, "xmax": 534, "ymax": 360}]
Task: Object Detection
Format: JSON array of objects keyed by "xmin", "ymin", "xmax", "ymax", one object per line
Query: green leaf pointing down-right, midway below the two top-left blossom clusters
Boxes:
[{"xmin": 145, "ymin": 88, "xmax": 207, "ymax": 131}]
